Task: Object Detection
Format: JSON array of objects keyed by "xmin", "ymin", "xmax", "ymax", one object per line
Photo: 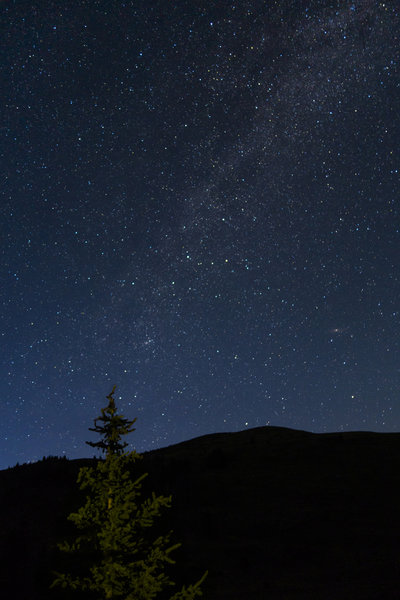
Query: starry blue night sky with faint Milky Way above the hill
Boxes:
[{"xmin": 0, "ymin": 0, "xmax": 400, "ymax": 468}]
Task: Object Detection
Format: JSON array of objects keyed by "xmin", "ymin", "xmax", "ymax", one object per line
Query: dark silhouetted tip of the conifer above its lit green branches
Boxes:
[{"xmin": 86, "ymin": 385, "xmax": 136, "ymax": 457}]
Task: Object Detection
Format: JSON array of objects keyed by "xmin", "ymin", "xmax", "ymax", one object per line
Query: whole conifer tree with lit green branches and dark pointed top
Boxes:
[{"xmin": 51, "ymin": 387, "xmax": 207, "ymax": 600}]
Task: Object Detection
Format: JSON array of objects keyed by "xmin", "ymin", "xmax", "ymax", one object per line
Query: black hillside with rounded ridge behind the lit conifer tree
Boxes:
[{"xmin": 0, "ymin": 427, "xmax": 400, "ymax": 600}]
